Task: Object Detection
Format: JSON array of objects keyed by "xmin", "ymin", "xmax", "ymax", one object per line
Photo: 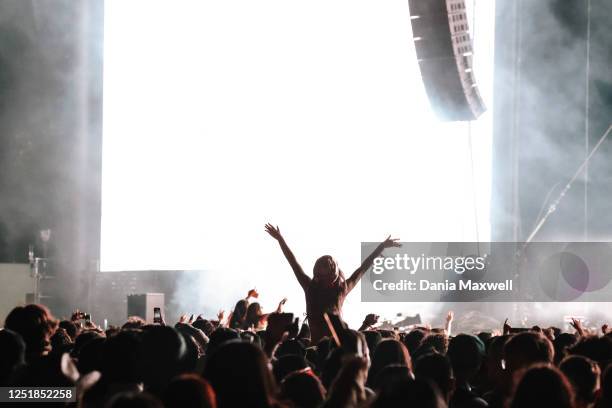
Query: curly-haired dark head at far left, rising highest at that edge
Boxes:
[{"xmin": 4, "ymin": 304, "xmax": 58, "ymax": 360}]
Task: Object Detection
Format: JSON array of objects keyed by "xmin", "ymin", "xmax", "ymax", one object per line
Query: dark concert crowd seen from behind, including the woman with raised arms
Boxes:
[{"xmin": 0, "ymin": 225, "xmax": 612, "ymax": 408}]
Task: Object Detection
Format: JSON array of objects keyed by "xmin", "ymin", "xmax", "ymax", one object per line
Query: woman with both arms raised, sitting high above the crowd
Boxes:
[{"xmin": 266, "ymin": 224, "xmax": 400, "ymax": 344}]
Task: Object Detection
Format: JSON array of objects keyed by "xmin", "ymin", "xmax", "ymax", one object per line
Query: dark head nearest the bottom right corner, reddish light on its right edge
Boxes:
[{"xmin": 559, "ymin": 356, "xmax": 601, "ymax": 406}]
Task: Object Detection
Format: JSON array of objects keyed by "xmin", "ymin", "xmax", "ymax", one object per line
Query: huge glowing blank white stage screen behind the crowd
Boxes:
[{"xmin": 100, "ymin": 0, "xmax": 494, "ymax": 322}]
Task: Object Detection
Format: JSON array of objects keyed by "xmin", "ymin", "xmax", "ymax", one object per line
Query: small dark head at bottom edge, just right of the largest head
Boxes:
[{"xmin": 281, "ymin": 371, "xmax": 325, "ymax": 408}]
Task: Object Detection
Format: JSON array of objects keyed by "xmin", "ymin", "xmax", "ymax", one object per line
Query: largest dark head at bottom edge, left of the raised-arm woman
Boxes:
[{"xmin": 203, "ymin": 340, "xmax": 276, "ymax": 408}]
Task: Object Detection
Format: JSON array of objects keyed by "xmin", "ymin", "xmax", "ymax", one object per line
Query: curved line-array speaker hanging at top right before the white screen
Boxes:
[{"xmin": 408, "ymin": 0, "xmax": 485, "ymax": 121}]
